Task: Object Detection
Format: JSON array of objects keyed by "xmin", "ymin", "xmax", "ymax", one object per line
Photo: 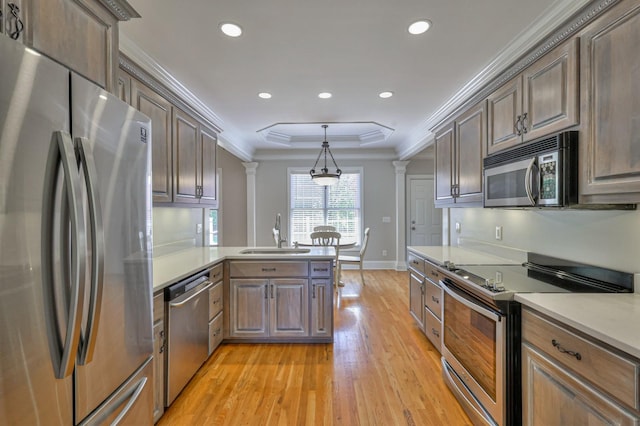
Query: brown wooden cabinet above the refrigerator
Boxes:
[{"xmin": 11, "ymin": 0, "xmax": 140, "ymax": 92}]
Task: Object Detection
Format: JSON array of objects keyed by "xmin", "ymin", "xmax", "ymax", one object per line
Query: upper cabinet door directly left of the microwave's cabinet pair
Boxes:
[{"xmin": 455, "ymin": 101, "xmax": 487, "ymax": 203}]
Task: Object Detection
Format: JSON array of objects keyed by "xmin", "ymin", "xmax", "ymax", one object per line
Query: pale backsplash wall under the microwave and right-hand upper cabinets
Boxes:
[{"xmin": 449, "ymin": 208, "xmax": 640, "ymax": 273}]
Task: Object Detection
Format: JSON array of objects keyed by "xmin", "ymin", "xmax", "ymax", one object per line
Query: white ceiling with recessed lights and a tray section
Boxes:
[{"xmin": 120, "ymin": 0, "xmax": 585, "ymax": 160}]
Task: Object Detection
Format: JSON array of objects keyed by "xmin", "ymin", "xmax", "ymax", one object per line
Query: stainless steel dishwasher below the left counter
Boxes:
[{"xmin": 165, "ymin": 270, "xmax": 213, "ymax": 407}]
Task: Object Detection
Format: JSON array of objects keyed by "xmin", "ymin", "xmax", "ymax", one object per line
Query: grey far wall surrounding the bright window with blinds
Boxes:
[{"xmin": 256, "ymin": 157, "xmax": 397, "ymax": 268}]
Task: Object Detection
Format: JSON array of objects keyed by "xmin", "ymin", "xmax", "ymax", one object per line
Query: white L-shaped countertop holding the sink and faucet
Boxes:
[{"xmin": 153, "ymin": 247, "xmax": 336, "ymax": 293}]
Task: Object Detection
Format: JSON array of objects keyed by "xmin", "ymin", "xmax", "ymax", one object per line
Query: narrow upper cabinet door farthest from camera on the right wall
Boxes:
[{"xmin": 435, "ymin": 123, "xmax": 455, "ymax": 204}]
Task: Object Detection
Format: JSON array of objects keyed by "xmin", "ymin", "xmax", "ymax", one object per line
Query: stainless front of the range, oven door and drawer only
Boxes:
[{"xmin": 440, "ymin": 278, "xmax": 507, "ymax": 425}]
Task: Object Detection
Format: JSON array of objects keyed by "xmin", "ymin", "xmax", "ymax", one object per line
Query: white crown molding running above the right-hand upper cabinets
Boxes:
[{"xmin": 398, "ymin": 0, "xmax": 620, "ymax": 158}]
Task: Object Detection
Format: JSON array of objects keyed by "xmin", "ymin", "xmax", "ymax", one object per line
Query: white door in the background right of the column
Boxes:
[{"xmin": 409, "ymin": 178, "xmax": 442, "ymax": 246}]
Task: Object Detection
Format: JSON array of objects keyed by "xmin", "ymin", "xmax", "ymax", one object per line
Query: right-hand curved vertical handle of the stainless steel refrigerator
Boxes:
[{"xmin": 75, "ymin": 138, "xmax": 104, "ymax": 365}]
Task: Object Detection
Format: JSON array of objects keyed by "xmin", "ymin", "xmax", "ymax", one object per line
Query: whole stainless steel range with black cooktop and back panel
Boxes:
[{"xmin": 440, "ymin": 253, "xmax": 634, "ymax": 426}]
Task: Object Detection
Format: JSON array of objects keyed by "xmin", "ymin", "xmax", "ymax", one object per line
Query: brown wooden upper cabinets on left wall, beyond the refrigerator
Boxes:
[{"xmin": 116, "ymin": 57, "xmax": 218, "ymax": 208}]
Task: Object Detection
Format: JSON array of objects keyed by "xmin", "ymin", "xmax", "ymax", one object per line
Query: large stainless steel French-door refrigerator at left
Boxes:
[{"xmin": 0, "ymin": 35, "xmax": 153, "ymax": 425}]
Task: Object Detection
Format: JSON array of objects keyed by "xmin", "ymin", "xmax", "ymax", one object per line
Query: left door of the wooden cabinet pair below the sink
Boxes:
[{"xmin": 229, "ymin": 278, "xmax": 269, "ymax": 337}]
